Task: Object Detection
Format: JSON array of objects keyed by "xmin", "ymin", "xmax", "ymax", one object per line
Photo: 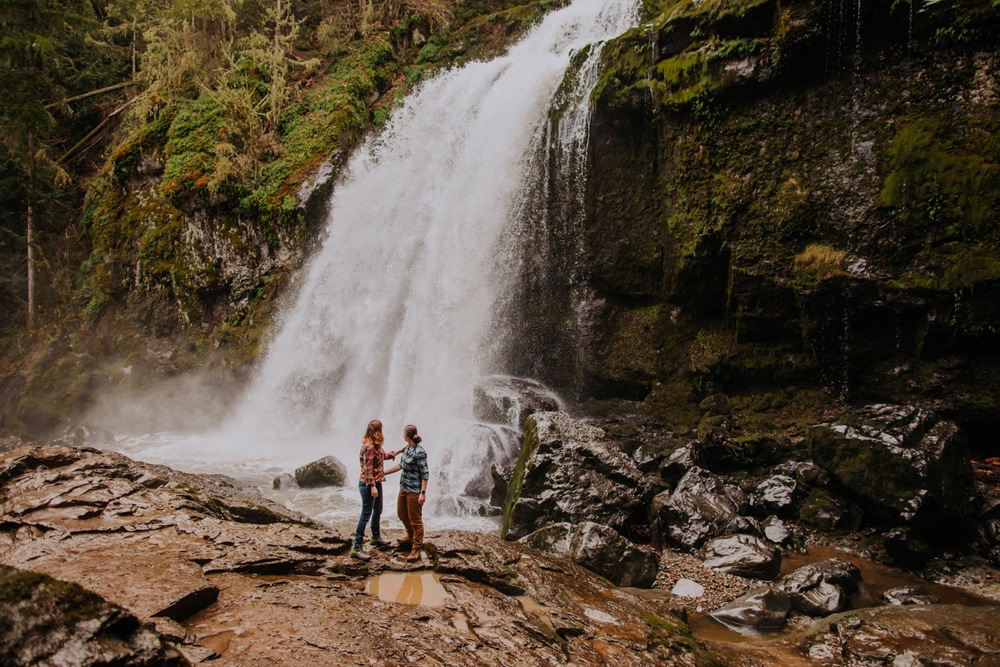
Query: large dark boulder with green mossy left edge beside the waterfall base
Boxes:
[{"xmin": 502, "ymin": 412, "xmax": 653, "ymax": 539}]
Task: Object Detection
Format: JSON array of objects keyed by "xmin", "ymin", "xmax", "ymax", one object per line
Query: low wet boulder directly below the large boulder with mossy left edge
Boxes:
[{"xmin": 519, "ymin": 521, "xmax": 659, "ymax": 588}]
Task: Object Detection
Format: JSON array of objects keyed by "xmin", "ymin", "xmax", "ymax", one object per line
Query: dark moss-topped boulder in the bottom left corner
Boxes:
[{"xmin": 0, "ymin": 565, "xmax": 189, "ymax": 667}]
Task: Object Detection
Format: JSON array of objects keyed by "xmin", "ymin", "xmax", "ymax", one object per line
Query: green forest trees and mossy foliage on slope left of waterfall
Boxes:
[{"xmin": 0, "ymin": 0, "xmax": 548, "ymax": 336}]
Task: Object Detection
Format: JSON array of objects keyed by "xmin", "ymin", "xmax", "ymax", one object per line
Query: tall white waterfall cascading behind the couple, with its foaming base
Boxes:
[{"xmin": 109, "ymin": 0, "xmax": 637, "ymax": 525}]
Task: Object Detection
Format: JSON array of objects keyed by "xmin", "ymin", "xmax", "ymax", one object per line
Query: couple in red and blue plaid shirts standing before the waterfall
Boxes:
[{"xmin": 351, "ymin": 419, "xmax": 429, "ymax": 562}]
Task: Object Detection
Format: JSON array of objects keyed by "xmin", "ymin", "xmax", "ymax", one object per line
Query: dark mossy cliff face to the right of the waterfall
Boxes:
[{"xmin": 584, "ymin": 0, "xmax": 1000, "ymax": 441}]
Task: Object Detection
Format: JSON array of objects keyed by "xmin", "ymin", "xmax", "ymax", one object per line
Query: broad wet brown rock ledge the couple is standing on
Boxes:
[{"xmin": 0, "ymin": 446, "xmax": 718, "ymax": 667}]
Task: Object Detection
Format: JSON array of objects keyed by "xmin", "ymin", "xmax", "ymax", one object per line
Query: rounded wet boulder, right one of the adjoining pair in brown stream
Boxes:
[{"xmin": 778, "ymin": 558, "xmax": 864, "ymax": 616}]
